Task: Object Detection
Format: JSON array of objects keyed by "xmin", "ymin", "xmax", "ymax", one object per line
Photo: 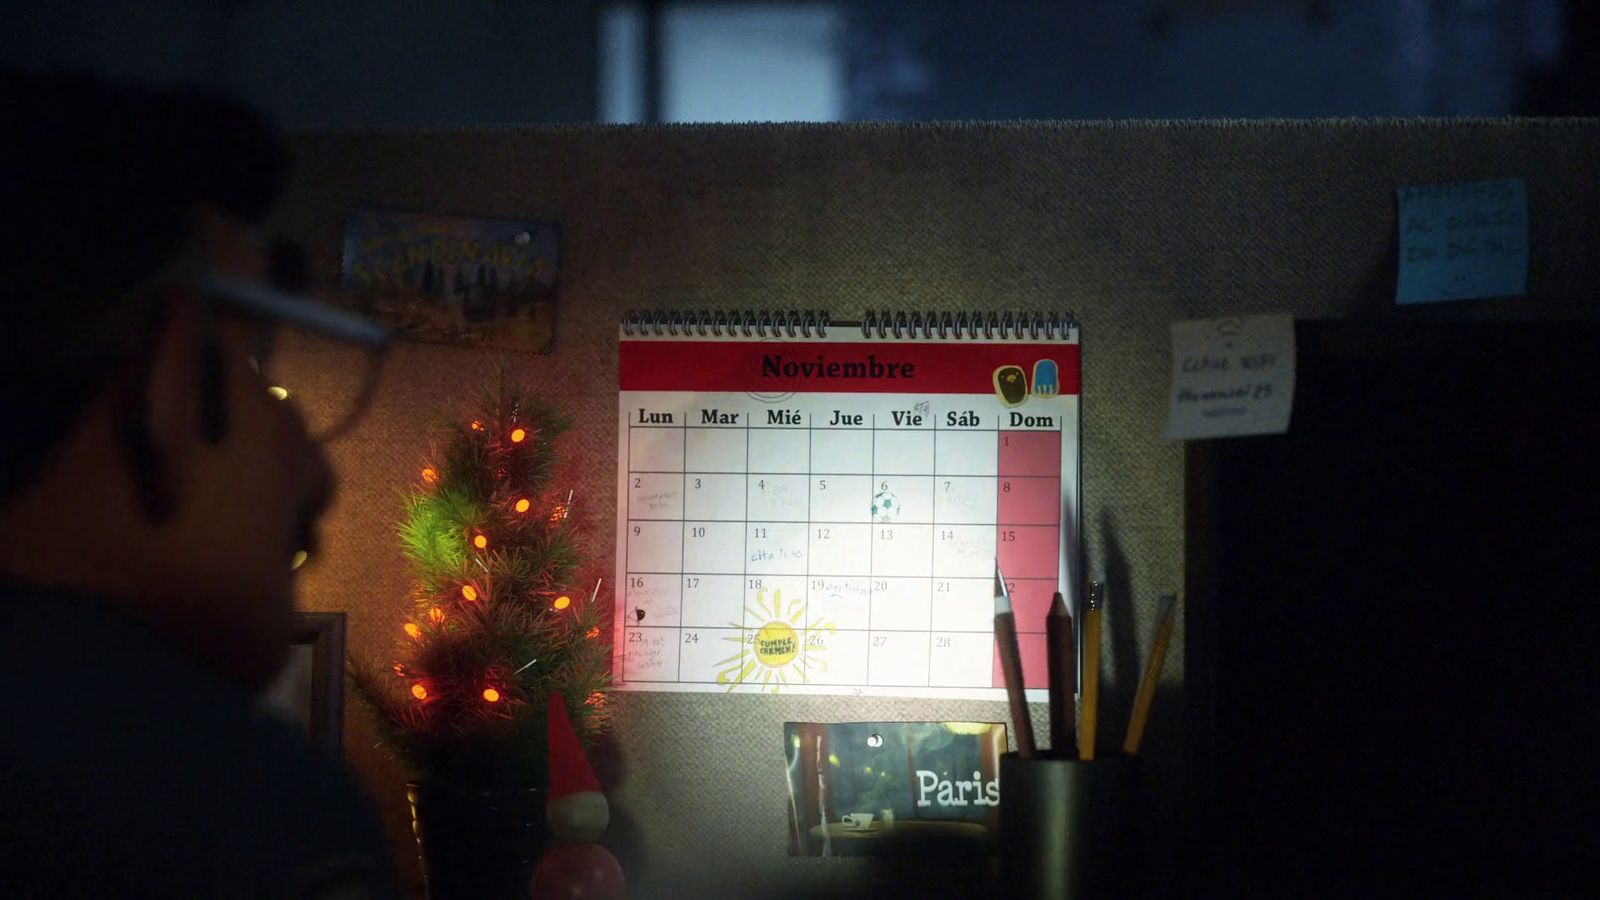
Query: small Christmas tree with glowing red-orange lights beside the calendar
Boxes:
[{"xmin": 350, "ymin": 365, "xmax": 611, "ymax": 788}]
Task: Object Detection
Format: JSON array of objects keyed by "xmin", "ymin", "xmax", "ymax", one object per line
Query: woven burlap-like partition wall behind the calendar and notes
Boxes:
[{"xmin": 278, "ymin": 120, "xmax": 1600, "ymax": 897}]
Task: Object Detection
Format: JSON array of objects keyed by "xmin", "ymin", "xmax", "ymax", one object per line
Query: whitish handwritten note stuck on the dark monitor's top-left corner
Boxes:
[{"xmin": 1166, "ymin": 314, "xmax": 1294, "ymax": 440}]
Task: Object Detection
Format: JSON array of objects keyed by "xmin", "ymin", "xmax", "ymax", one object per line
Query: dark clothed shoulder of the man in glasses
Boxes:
[{"xmin": 0, "ymin": 589, "xmax": 396, "ymax": 892}]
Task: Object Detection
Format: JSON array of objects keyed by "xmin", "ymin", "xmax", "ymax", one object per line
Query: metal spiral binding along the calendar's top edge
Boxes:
[{"xmin": 622, "ymin": 309, "xmax": 1078, "ymax": 341}]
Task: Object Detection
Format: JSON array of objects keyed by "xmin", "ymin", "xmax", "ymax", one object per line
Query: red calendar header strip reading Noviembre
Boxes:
[{"xmin": 618, "ymin": 340, "xmax": 1078, "ymax": 394}]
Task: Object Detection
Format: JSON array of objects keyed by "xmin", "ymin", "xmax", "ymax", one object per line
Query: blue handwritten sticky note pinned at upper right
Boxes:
[{"xmin": 1395, "ymin": 178, "xmax": 1528, "ymax": 303}]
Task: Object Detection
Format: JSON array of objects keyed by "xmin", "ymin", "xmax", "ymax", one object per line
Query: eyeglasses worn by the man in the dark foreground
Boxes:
[{"xmin": 198, "ymin": 272, "xmax": 390, "ymax": 442}]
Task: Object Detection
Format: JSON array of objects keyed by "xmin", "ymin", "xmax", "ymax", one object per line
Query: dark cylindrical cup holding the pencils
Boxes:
[{"xmin": 1000, "ymin": 753, "xmax": 1139, "ymax": 900}]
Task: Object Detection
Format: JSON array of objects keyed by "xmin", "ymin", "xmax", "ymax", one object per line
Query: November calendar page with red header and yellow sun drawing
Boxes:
[{"xmin": 614, "ymin": 328, "xmax": 1078, "ymax": 700}]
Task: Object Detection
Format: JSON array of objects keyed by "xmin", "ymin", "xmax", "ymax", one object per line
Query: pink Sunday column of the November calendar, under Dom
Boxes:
[{"xmin": 994, "ymin": 429, "xmax": 1061, "ymax": 689}]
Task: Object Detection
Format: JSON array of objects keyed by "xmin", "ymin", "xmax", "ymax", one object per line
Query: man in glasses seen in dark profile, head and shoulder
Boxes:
[{"xmin": 0, "ymin": 69, "xmax": 394, "ymax": 898}]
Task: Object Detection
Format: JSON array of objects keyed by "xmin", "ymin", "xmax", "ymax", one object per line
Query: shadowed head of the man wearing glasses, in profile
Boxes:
[{"xmin": 0, "ymin": 69, "xmax": 350, "ymax": 687}]
